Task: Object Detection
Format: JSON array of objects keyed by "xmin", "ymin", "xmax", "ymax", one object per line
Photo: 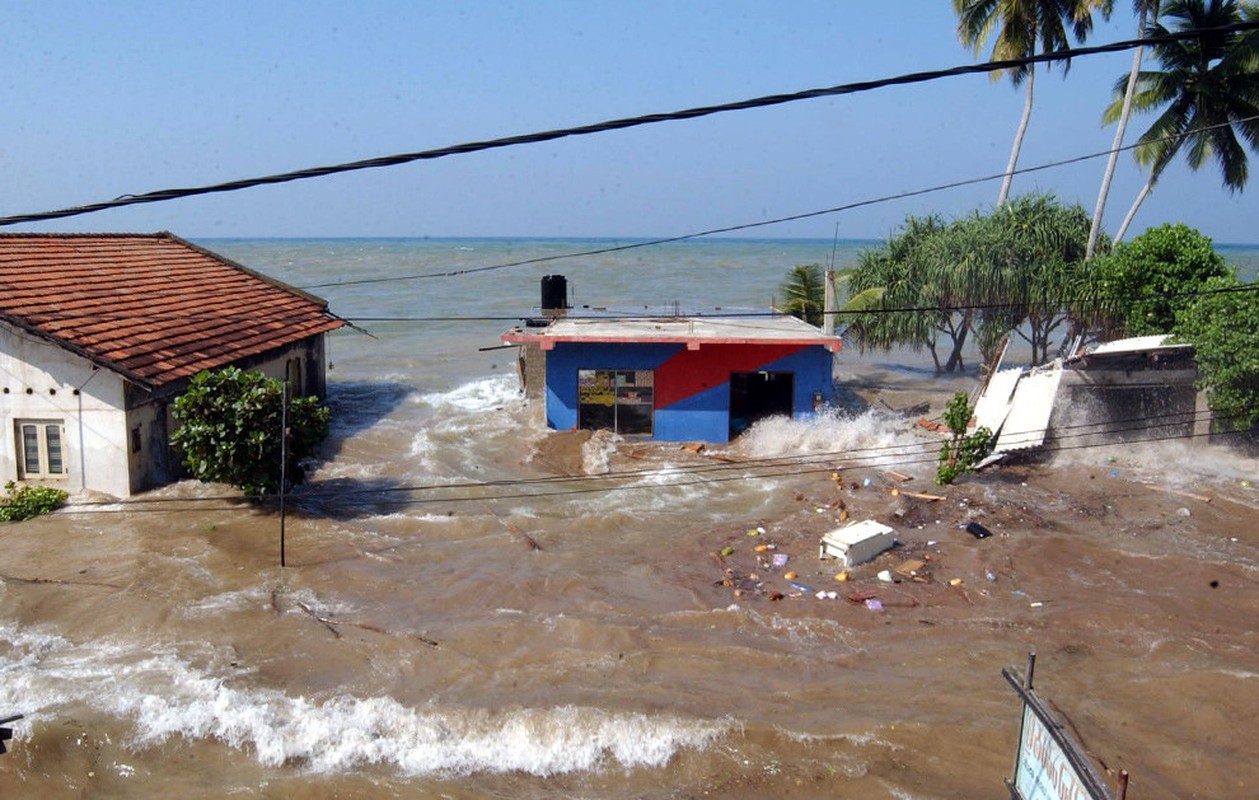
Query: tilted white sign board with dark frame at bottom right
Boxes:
[{"xmin": 1001, "ymin": 656, "xmax": 1127, "ymax": 800}]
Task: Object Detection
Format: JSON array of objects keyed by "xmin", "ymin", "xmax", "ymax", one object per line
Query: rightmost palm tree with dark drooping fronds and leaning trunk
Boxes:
[{"xmin": 1104, "ymin": 0, "xmax": 1259, "ymax": 242}]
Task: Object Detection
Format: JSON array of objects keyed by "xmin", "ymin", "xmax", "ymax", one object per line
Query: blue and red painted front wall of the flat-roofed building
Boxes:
[{"xmin": 546, "ymin": 343, "xmax": 833, "ymax": 442}]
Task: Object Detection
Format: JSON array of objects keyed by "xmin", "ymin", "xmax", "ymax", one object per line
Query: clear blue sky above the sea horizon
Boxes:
[{"xmin": 0, "ymin": 0, "xmax": 1259, "ymax": 243}]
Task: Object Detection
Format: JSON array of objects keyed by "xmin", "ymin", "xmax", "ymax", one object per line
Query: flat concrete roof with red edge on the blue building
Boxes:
[{"xmin": 502, "ymin": 315, "xmax": 844, "ymax": 353}]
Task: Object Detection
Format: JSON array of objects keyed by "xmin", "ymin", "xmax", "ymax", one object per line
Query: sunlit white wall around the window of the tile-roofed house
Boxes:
[{"xmin": 0, "ymin": 323, "xmax": 131, "ymax": 498}]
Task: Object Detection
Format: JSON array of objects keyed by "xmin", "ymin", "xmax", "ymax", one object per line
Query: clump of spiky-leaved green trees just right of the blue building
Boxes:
[{"xmin": 841, "ymin": 194, "xmax": 1089, "ymax": 372}]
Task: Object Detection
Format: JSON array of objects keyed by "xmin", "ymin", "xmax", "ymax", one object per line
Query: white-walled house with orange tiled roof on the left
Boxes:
[{"xmin": 0, "ymin": 233, "xmax": 344, "ymax": 498}]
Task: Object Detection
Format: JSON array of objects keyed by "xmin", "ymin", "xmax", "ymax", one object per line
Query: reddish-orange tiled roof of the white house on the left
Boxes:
[{"xmin": 0, "ymin": 233, "xmax": 344, "ymax": 387}]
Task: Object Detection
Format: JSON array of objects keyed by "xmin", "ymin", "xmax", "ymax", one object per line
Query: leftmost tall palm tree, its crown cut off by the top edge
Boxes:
[{"xmin": 953, "ymin": 0, "xmax": 1114, "ymax": 205}]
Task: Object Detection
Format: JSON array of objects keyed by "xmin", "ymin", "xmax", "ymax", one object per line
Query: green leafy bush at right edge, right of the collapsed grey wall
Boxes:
[{"xmin": 1176, "ymin": 276, "xmax": 1259, "ymax": 431}]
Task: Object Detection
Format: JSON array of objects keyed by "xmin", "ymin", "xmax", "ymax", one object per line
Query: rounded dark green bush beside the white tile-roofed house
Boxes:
[{"xmin": 171, "ymin": 367, "xmax": 329, "ymax": 496}]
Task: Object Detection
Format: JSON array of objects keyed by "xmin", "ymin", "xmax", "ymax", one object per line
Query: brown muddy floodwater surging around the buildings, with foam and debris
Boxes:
[{"xmin": 0, "ymin": 239, "xmax": 1259, "ymax": 800}]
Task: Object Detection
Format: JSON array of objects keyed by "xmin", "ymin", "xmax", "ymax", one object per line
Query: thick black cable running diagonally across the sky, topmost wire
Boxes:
[{"xmin": 0, "ymin": 21, "xmax": 1259, "ymax": 227}]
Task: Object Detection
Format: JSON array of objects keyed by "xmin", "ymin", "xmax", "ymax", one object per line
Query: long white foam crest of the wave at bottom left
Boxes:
[{"xmin": 0, "ymin": 625, "xmax": 731, "ymax": 776}]
